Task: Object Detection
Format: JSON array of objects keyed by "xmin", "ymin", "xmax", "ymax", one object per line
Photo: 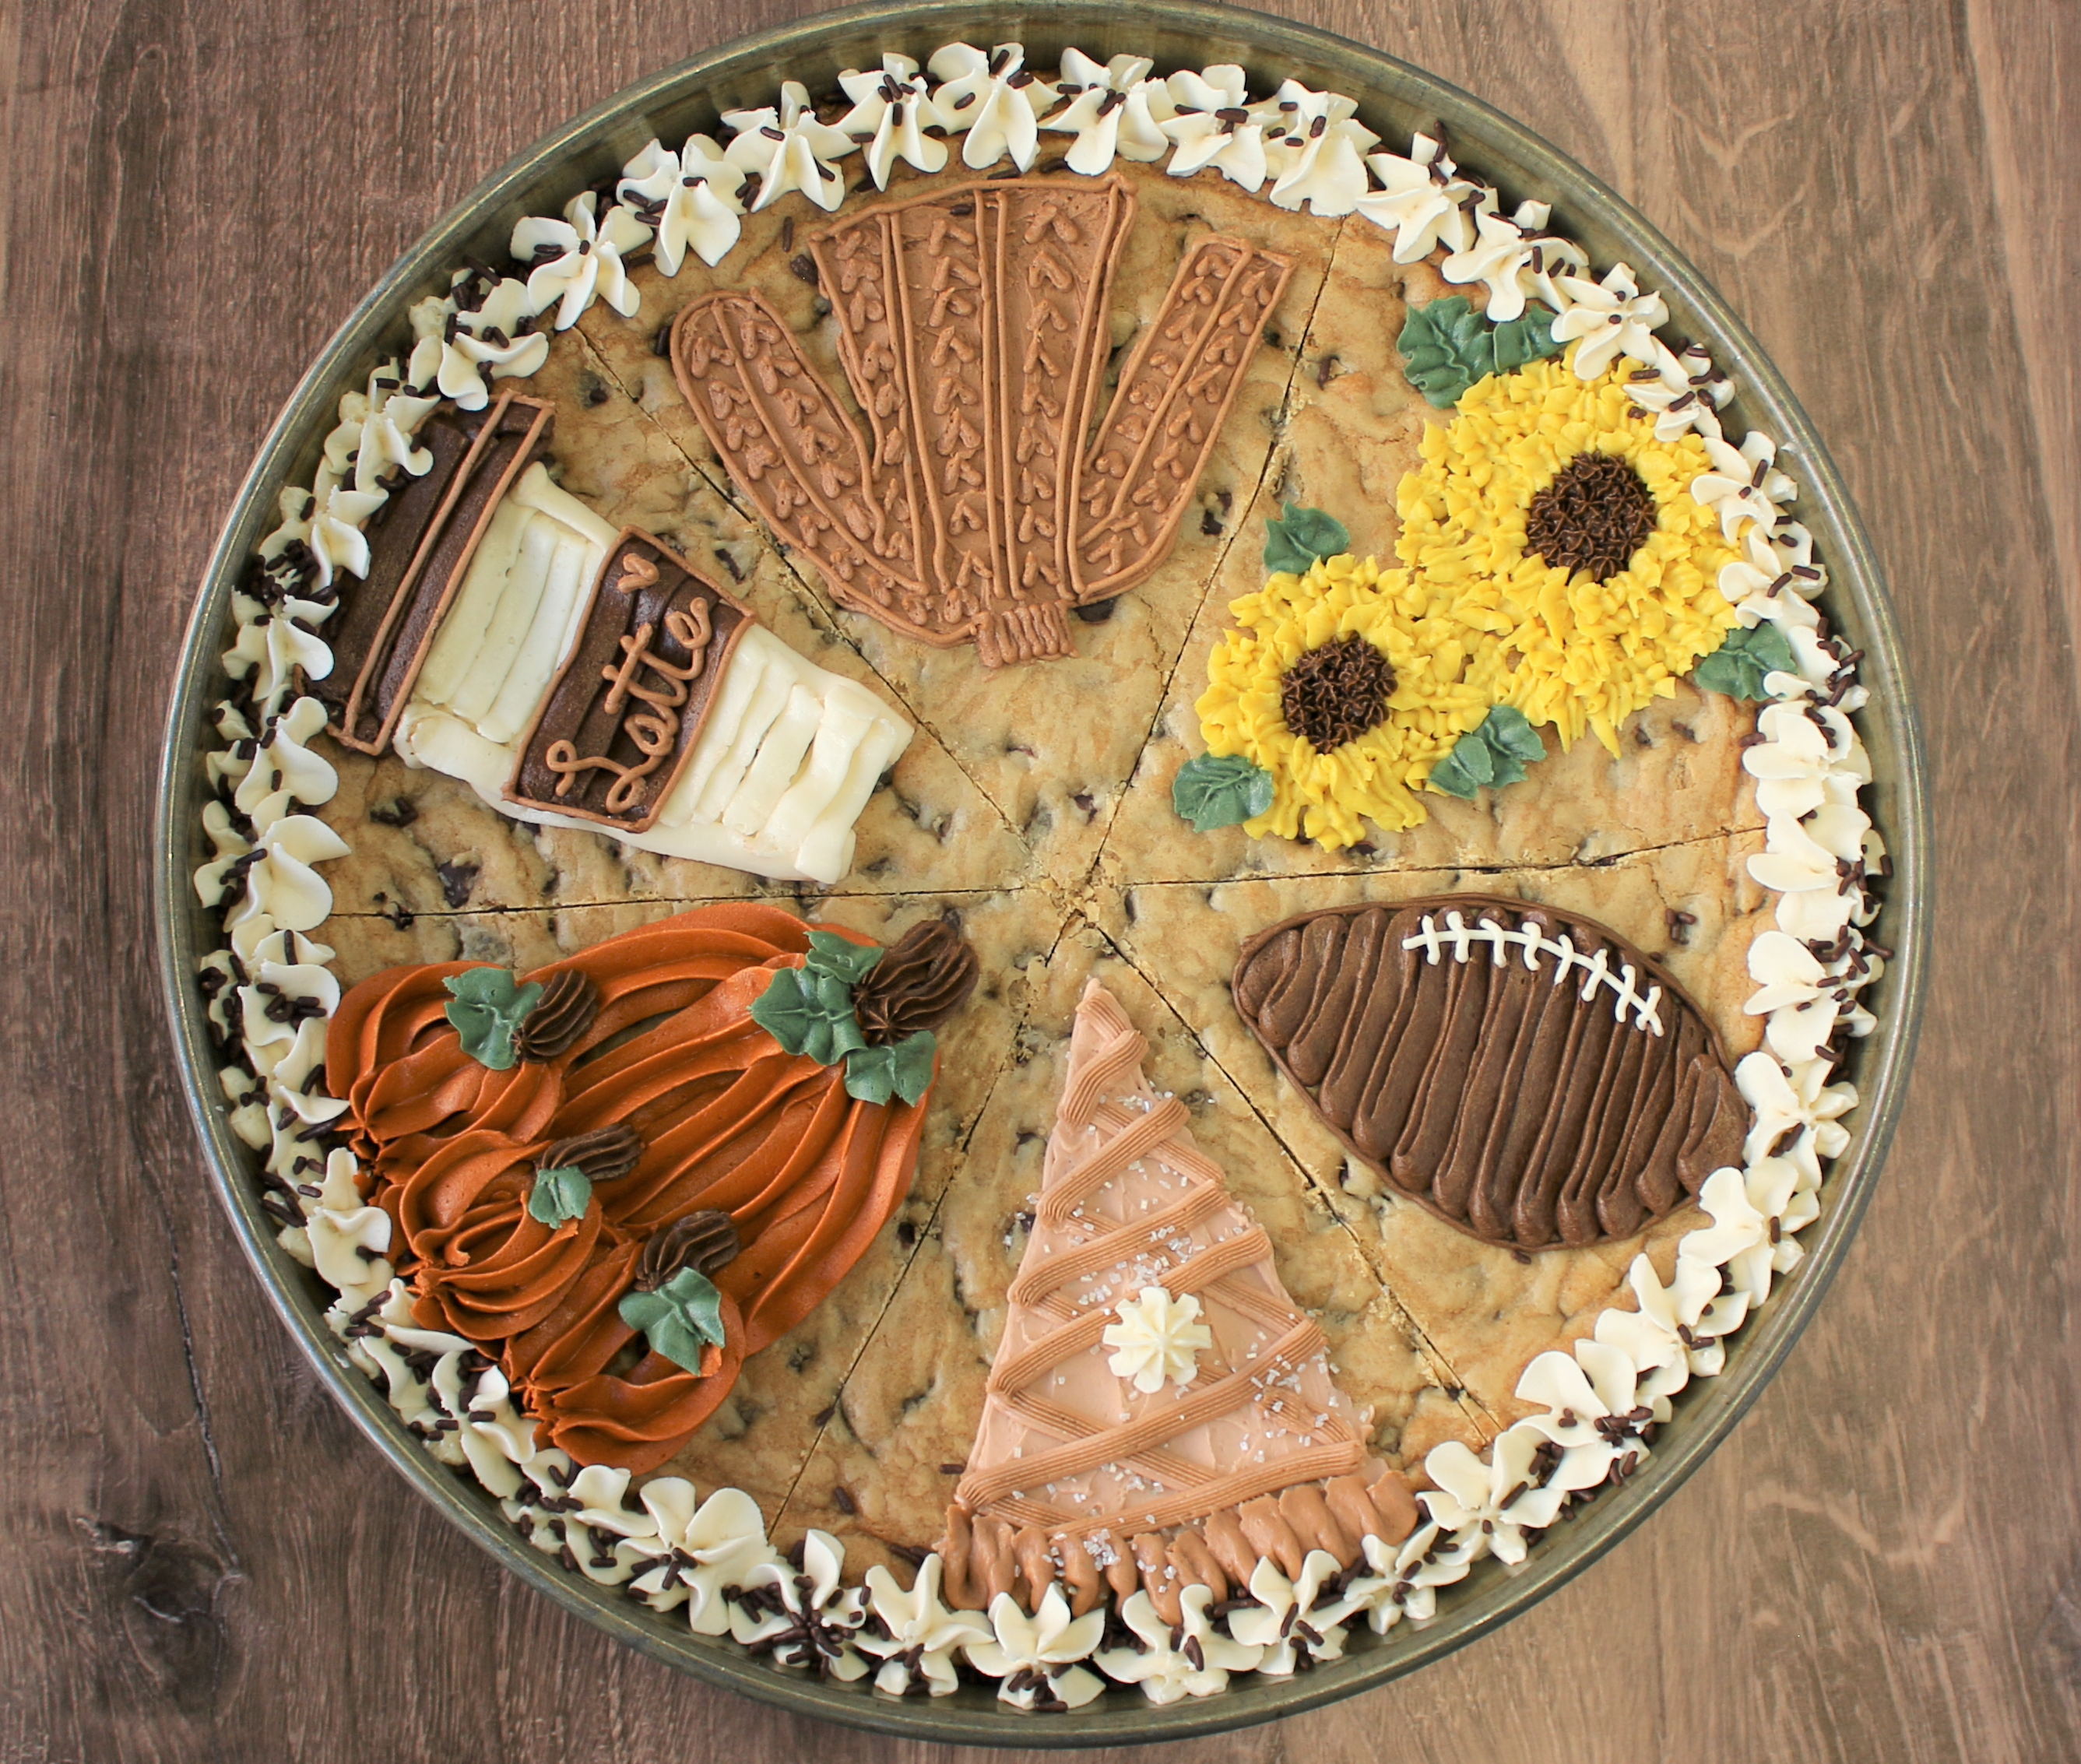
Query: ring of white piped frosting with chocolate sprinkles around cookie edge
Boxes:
[{"xmin": 195, "ymin": 44, "xmax": 1886, "ymax": 1708}]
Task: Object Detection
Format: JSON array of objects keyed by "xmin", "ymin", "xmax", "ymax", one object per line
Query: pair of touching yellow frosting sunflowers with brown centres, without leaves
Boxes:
[{"xmin": 1199, "ymin": 346, "xmax": 1738, "ymax": 849}]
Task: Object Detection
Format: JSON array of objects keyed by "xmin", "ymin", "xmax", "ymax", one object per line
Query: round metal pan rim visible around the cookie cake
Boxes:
[{"xmin": 154, "ymin": 0, "xmax": 1929, "ymax": 1748}]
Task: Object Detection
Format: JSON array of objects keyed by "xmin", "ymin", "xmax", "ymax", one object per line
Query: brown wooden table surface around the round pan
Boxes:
[{"xmin": 0, "ymin": 0, "xmax": 2081, "ymax": 1764}]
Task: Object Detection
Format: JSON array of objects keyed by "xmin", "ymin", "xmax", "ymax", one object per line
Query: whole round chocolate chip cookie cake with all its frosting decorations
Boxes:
[{"xmin": 194, "ymin": 44, "xmax": 1887, "ymax": 1718}]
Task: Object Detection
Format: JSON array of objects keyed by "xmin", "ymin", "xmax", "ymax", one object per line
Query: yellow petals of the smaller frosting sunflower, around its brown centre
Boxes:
[{"xmin": 1199, "ymin": 555, "xmax": 1490, "ymax": 847}]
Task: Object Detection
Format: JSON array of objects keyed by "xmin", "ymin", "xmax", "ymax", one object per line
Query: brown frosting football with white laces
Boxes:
[{"xmin": 1234, "ymin": 894, "xmax": 1748, "ymax": 1250}]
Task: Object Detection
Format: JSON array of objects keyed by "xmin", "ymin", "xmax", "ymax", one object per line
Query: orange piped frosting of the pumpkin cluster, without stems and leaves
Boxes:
[{"xmin": 327, "ymin": 905, "xmax": 939, "ymax": 1473}]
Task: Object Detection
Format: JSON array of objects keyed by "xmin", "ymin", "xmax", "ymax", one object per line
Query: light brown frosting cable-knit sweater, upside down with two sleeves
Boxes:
[{"xmin": 672, "ymin": 177, "xmax": 1292, "ymax": 668}]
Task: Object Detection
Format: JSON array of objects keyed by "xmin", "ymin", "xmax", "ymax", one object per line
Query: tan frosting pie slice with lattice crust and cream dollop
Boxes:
[{"xmin": 940, "ymin": 980, "xmax": 1415, "ymax": 1622}]
